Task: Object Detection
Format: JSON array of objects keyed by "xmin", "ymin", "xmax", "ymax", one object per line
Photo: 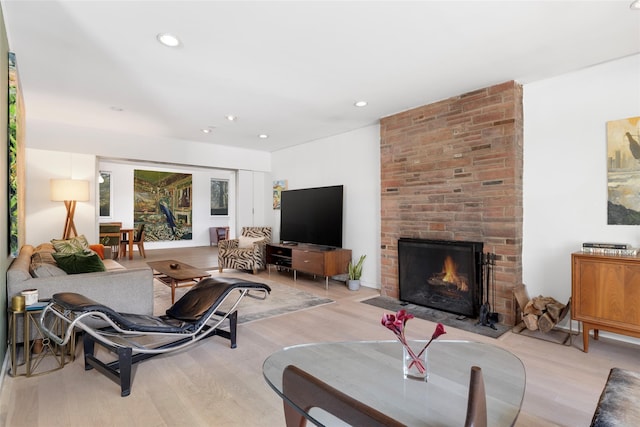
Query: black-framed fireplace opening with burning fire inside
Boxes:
[{"xmin": 398, "ymin": 238, "xmax": 483, "ymax": 318}]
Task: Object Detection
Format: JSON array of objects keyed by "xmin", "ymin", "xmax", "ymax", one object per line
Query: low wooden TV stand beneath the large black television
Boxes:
[{"xmin": 267, "ymin": 243, "xmax": 351, "ymax": 289}]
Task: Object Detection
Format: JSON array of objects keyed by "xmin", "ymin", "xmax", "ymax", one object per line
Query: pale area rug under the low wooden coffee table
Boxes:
[{"xmin": 153, "ymin": 270, "xmax": 334, "ymax": 324}]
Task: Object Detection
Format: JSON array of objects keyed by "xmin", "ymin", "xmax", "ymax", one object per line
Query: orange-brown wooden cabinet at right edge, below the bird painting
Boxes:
[{"xmin": 571, "ymin": 252, "xmax": 640, "ymax": 352}]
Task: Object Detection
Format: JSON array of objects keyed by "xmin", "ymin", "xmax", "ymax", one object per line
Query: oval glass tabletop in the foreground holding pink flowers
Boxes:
[{"xmin": 262, "ymin": 340, "xmax": 525, "ymax": 426}]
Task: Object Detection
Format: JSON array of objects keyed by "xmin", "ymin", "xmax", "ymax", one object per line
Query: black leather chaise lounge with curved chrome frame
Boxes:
[{"xmin": 40, "ymin": 278, "xmax": 271, "ymax": 397}]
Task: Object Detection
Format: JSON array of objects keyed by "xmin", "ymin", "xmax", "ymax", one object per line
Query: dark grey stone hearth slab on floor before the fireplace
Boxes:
[{"xmin": 362, "ymin": 296, "xmax": 510, "ymax": 338}]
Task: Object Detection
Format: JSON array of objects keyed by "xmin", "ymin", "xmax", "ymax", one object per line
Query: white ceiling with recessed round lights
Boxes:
[{"xmin": 1, "ymin": 0, "xmax": 640, "ymax": 151}]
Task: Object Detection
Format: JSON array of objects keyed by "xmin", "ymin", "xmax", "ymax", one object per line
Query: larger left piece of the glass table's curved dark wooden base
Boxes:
[{"xmin": 282, "ymin": 365, "xmax": 404, "ymax": 427}]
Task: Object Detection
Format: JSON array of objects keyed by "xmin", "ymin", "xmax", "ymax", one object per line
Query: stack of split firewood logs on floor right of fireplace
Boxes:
[{"xmin": 514, "ymin": 285, "xmax": 569, "ymax": 333}]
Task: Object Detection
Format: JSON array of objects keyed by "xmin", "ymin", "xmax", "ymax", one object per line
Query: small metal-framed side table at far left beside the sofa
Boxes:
[{"xmin": 9, "ymin": 307, "xmax": 66, "ymax": 377}]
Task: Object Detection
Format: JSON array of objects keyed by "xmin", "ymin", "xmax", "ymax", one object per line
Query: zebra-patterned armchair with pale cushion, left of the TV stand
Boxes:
[{"xmin": 218, "ymin": 227, "xmax": 271, "ymax": 274}]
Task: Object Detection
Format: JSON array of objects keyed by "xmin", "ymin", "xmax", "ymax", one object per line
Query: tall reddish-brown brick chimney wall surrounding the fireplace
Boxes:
[{"xmin": 380, "ymin": 81, "xmax": 523, "ymax": 325}]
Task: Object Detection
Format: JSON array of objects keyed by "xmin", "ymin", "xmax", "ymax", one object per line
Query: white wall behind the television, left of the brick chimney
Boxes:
[{"xmin": 271, "ymin": 125, "xmax": 380, "ymax": 288}]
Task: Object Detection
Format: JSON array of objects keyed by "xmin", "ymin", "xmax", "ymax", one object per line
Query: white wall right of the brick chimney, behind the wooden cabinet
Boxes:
[{"xmin": 523, "ymin": 55, "xmax": 640, "ymax": 308}]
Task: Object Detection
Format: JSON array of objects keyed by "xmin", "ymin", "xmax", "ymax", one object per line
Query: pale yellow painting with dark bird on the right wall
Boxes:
[{"xmin": 607, "ymin": 117, "xmax": 640, "ymax": 225}]
